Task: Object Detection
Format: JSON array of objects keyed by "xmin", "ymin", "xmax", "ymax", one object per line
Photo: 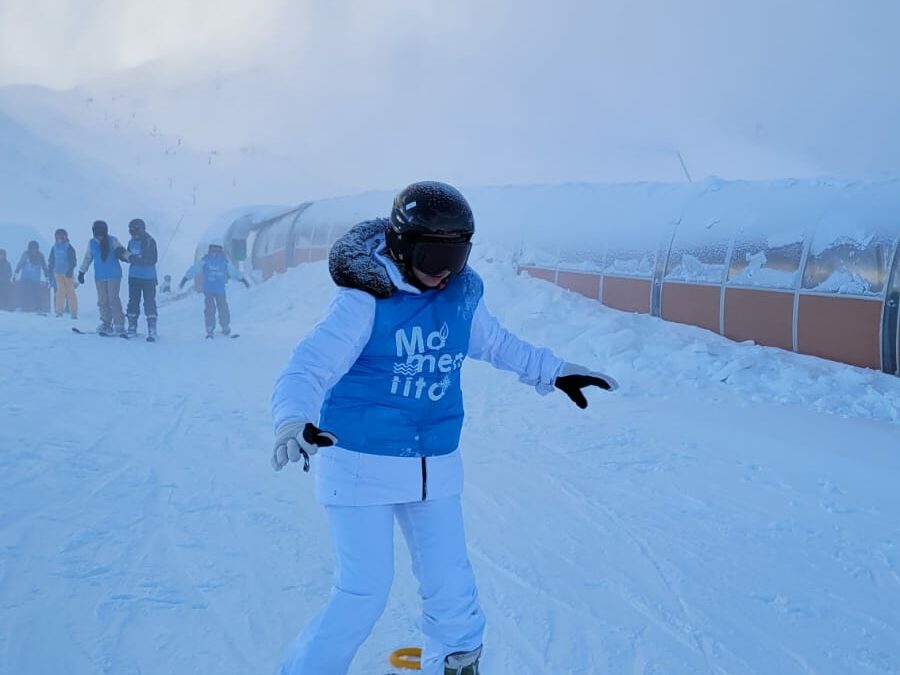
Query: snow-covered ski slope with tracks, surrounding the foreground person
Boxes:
[{"xmin": 0, "ymin": 255, "xmax": 900, "ymax": 675}]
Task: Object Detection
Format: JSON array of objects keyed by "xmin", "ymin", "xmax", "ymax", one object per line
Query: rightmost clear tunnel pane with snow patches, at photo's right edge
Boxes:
[{"xmin": 803, "ymin": 218, "xmax": 897, "ymax": 297}]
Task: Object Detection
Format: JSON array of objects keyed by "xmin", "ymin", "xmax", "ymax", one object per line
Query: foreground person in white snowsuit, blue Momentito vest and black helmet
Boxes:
[{"xmin": 272, "ymin": 182, "xmax": 617, "ymax": 675}]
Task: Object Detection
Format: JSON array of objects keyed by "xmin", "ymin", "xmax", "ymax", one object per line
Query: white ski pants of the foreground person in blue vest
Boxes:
[{"xmin": 278, "ymin": 495, "xmax": 484, "ymax": 675}]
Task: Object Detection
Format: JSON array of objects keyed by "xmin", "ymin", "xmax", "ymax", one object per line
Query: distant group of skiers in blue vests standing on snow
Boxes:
[{"xmin": 0, "ymin": 218, "xmax": 250, "ymax": 339}]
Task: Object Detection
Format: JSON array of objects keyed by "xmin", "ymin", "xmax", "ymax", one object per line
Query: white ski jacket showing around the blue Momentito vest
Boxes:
[{"xmin": 272, "ymin": 238, "xmax": 563, "ymax": 506}]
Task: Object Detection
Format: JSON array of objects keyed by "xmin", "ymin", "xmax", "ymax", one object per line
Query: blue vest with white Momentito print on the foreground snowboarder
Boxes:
[{"xmin": 321, "ymin": 267, "xmax": 483, "ymax": 457}]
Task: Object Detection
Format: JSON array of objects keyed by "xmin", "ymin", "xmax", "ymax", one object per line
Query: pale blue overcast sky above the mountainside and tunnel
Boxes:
[{"xmin": 0, "ymin": 0, "xmax": 900, "ymax": 191}]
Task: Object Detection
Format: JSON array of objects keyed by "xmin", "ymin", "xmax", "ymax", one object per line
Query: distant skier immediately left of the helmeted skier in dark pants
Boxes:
[{"xmin": 78, "ymin": 220, "xmax": 126, "ymax": 335}]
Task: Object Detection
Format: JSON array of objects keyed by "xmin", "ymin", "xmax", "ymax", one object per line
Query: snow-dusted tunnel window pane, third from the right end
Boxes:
[{"xmin": 664, "ymin": 218, "xmax": 734, "ymax": 284}]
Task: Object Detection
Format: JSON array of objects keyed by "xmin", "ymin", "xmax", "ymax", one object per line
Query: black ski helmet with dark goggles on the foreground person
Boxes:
[{"xmin": 385, "ymin": 181, "xmax": 475, "ymax": 275}]
